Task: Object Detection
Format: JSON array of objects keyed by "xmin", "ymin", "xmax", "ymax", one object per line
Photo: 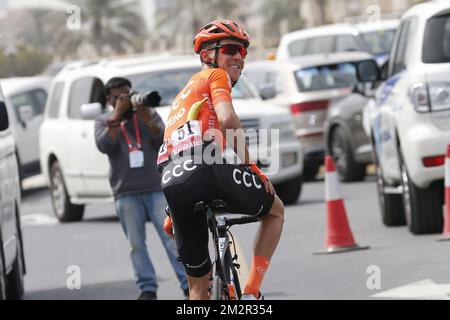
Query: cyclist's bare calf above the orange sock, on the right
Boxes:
[{"xmin": 253, "ymin": 195, "xmax": 284, "ymax": 260}]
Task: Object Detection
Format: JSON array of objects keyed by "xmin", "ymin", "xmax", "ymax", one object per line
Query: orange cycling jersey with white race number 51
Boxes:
[{"xmin": 157, "ymin": 69, "xmax": 232, "ymax": 164}]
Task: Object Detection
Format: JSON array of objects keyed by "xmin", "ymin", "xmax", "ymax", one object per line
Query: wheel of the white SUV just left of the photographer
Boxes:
[{"xmin": 50, "ymin": 161, "xmax": 84, "ymax": 222}]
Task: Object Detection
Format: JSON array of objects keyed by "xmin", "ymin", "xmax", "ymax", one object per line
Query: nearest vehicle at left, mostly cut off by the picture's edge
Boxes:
[{"xmin": 0, "ymin": 82, "xmax": 25, "ymax": 299}]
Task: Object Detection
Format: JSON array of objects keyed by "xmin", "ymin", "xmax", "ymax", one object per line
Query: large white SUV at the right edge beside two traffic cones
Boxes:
[{"xmin": 360, "ymin": 1, "xmax": 450, "ymax": 234}]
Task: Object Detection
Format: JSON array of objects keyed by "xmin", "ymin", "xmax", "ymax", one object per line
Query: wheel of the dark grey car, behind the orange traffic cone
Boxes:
[{"xmin": 330, "ymin": 127, "xmax": 366, "ymax": 182}]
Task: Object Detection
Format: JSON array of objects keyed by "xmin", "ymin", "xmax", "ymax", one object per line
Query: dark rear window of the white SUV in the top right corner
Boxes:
[{"xmin": 422, "ymin": 15, "xmax": 450, "ymax": 63}]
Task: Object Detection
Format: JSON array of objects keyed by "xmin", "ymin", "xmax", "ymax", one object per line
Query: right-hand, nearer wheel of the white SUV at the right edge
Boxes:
[{"xmin": 400, "ymin": 154, "xmax": 443, "ymax": 234}]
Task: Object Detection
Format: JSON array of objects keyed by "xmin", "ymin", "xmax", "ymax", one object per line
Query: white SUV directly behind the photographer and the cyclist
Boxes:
[{"xmin": 40, "ymin": 56, "xmax": 303, "ymax": 221}]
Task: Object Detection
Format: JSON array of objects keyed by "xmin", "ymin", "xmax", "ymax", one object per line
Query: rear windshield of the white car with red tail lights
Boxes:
[{"xmin": 295, "ymin": 63, "xmax": 356, "ymax": 91}]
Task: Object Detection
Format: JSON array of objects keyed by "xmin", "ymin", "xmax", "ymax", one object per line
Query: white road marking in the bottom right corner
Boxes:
[{"xmin": 371, "ymin": 279, "xmax": 450, "ymax": 300}]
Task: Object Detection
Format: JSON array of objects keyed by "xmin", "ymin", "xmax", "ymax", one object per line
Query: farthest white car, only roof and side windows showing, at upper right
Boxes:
[{"xmin": 276, "ymin": 20, "xmax": 398, "ymax": 65}]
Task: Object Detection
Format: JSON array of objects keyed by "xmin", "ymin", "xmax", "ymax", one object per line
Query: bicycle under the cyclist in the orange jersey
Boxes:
[{"xmin": 166, "ymin": 199, "xmax": 260, "ymax": 300}]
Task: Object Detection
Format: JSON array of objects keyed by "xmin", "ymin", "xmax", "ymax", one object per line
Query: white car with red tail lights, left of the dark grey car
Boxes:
[{"xmin": 244, "ymin": 52, "xmax": 372, "ymax": 180}]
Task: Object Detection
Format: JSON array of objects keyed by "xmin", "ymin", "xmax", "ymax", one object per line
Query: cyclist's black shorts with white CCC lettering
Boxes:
[{"xmin": 161, "ymin": 155, "xmax": 274, "ymax": 277}]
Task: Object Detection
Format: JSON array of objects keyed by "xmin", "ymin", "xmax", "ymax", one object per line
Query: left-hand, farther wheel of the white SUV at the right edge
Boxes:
[{"xmin": 375, "ymin": 161, "xmax": 406, "ymax": 227}]
